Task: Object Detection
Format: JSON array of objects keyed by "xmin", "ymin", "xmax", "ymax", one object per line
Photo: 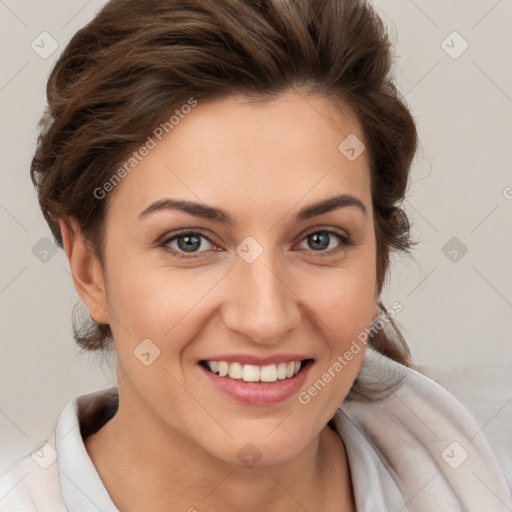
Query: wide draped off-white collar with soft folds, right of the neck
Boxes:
[{"xmin": 334, "ymin": 347, "xmax": 512, "ymax": 512}]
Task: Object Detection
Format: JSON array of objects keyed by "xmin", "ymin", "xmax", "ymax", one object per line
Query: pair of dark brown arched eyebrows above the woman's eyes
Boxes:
[{"xmin": 139, "ymin": 194, "xmax": 367, "ymax": 226}]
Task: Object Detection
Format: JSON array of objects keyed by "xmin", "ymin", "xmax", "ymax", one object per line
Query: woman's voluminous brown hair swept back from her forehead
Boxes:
[{"xmin": 30, "ymin": 0, "xmax": 417, "ymax": 398}]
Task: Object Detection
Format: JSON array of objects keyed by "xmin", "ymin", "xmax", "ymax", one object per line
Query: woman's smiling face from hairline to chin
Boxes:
[{"xmin": 83, "ymin": 93, "xmax": 376, "ymax": 464}]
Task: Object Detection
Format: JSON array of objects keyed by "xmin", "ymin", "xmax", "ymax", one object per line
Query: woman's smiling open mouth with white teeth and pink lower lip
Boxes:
[{"xmin": 198, "ymin": 358, "xmax": 314, "ymax": 405}]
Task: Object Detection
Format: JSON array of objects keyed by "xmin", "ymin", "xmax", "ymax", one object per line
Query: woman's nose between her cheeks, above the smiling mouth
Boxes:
[{"xmin": 223, "ymin": 251, "xmax": 301, "ymax": 344}]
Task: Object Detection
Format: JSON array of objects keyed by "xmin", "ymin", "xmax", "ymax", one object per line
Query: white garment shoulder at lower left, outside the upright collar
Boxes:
[{"xmin": 0, "ymin": 433, "xmax": 67, "ymax": 512}]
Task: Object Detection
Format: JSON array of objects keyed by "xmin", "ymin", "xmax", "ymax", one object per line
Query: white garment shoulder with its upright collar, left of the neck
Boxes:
[{"xmin": 0, "ymin": 386, "xmax": 118, "ymax": 512}]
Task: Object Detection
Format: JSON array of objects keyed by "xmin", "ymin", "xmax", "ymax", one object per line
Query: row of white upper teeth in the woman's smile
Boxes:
[{"xmin": 206, "ymin": 361, "xmax": 301, "ymax": 382}]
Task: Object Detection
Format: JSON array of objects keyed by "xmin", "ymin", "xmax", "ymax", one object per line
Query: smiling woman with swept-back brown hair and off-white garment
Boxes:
[{"xmin": 0, "ymin": 0, "xmax": 512, "ymax": 512}]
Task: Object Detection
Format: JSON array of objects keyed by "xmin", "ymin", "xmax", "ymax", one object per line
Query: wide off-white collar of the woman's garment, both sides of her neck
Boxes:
[{"xmin": 55, "ymin": 346, "xmax": 512, "ymax": 512}]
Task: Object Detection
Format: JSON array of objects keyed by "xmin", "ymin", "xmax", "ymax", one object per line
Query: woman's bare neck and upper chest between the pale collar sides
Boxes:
[{"xmin": 85, "ymin": 390, "xmax": 354, "ymax": 512}]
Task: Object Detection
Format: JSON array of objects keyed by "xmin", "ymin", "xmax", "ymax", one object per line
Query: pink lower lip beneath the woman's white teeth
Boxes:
[{"xmin": 198, "ymin": 363, "xmax": 312, "ymax": 405}]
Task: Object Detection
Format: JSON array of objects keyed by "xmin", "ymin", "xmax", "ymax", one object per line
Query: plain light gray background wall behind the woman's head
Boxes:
[{"xmin": 0, "ymin": 0, "xmax": 512, "ymax": 470}]
